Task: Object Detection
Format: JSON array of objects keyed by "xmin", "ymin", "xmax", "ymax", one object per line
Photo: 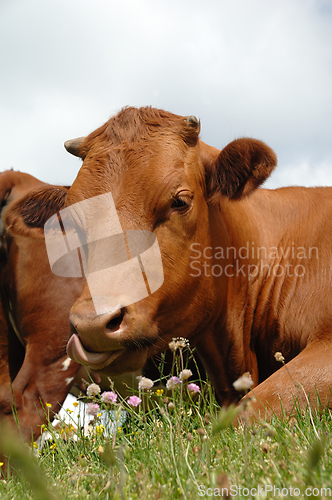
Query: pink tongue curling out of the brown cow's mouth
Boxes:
[{"xmin": 67, "ymin": 333, "xmax": 122, "ymax": 370}]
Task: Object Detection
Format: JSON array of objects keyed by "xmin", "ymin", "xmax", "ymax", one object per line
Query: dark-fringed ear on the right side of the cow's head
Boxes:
[{"xmin": 201, "ymin": 138, "xmax": 277, "ymax": 200}]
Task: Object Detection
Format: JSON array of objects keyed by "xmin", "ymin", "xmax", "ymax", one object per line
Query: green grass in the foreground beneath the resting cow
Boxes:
[{"xmin": 0, "ymin": 344, "xmax": 332, "ymax": 500}]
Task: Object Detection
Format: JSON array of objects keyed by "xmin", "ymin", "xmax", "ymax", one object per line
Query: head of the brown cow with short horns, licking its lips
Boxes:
[{"xmin": 66, "ymin": 108, "xmax": 276, "ymax": 374}]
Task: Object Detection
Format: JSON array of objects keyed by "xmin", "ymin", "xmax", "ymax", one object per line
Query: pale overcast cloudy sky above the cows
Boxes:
[{"xmin": 0, "ymin": 0, "xmax": 332, "ymax": 188}]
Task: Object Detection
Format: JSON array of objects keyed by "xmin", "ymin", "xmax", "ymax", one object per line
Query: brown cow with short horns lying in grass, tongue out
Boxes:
[{"xmin": 66, "ymin": 108, "xmax": 332, "ymax": 420}]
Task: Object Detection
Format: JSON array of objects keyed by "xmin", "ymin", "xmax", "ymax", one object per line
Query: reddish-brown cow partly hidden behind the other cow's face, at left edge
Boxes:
[{"xmin": 0, "ymin": 171, "xmax": 84, "ymax": 439}]
